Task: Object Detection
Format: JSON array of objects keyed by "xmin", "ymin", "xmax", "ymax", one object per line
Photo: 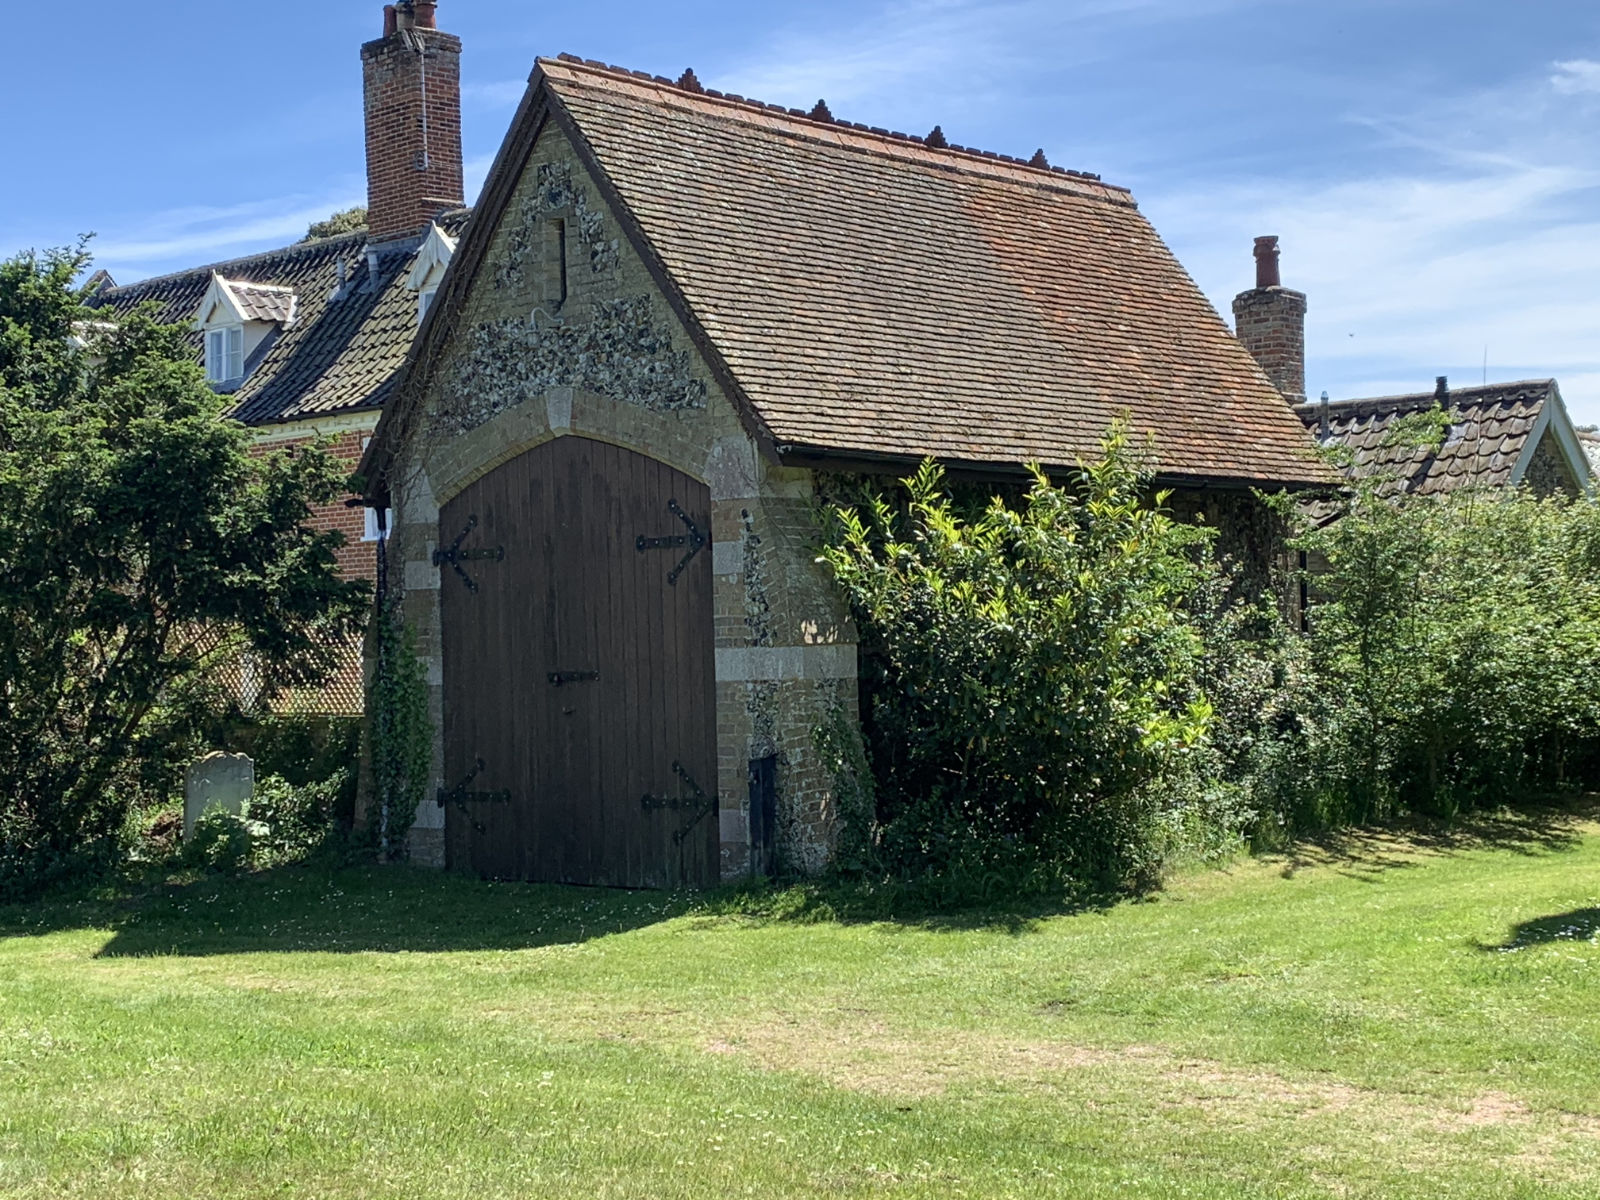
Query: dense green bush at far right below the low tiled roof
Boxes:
[{"xmin": 1277, "ymin": 488, "xmax": 1600, "ymax": 824}]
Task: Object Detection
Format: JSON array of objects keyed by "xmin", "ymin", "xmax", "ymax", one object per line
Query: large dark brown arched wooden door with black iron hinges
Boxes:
[{"xmin": 437, "ymin": 437, "xmax": 720, "ymax": 888}]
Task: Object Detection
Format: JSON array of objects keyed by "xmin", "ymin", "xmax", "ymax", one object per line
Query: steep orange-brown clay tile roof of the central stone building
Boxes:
[{"xmin": 536, "ymin": 58, "xmax": 1331, "ymax": 483}]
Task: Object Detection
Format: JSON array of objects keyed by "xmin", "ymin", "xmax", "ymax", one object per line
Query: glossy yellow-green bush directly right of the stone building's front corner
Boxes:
[{"xmin": 824, "ymin": 427, "xmax": 1210, "ymax": 888}]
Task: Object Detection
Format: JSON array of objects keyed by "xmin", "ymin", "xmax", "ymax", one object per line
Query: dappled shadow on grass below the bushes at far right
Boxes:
[{"xmin": 1278, "ymin": 795, "xmax": 1600, "ymax": 883}]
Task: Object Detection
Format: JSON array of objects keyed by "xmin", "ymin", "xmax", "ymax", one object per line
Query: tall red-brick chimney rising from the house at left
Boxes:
[{"xmin": 362, "ymin": 0, "xmax": 466, "ymax": 242}]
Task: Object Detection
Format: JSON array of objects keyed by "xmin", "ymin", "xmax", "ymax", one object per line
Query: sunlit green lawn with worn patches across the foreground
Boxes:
[{"xmin": 0, "ymin": 818, "xmax": 1600, "ymax": 1200}]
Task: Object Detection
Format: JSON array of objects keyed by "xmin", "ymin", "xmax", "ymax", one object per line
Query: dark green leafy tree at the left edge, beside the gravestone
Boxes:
[{"xmin": 0, "ymin": 246, "xmax": 365, "ymax": 890}]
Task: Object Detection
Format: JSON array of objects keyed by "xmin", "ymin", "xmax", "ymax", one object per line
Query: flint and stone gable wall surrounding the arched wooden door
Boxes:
[{"xmin": 390, "ymin": 126, "xmax": 856, "ymax": 877}]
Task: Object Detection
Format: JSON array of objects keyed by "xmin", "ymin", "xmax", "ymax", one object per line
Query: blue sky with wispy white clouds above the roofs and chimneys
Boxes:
[{"xmin": 0, "ymin": 0, "xmax": 1600, "ymax": 422}]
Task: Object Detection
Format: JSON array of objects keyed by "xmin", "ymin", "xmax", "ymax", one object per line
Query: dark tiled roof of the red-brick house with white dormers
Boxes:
[{"xmin": 91, "ymin": 210, "xmax": 470, "ymax": 426}]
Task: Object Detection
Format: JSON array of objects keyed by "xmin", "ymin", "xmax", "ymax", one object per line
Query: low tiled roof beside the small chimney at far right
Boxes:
[{"xmin": 1294, "ymin": 379, "xmax": 1566, "ymax": 496}]
